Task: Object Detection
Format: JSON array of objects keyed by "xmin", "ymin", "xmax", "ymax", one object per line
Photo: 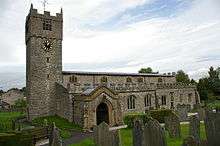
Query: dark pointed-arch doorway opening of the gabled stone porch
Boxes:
[{"xmin": 96, "ymin": 102, "xmax": 109, "ymax": 125}]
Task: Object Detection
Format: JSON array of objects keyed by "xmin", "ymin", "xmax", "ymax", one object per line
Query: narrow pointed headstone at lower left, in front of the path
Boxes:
[{"xmin": 49, "ymin": 123, "xmax": 62, "ymax": 146}]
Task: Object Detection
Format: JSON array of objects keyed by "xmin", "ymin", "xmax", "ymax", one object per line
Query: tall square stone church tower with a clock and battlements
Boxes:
[{"xmin": 25, "ymin": 4, "xmax": 63, "ymax": 120}]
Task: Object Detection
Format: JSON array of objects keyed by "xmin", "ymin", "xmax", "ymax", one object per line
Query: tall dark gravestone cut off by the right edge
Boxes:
[{"xmin": 205, "ymin": 110, "xmax": 220, "ymax": 146}]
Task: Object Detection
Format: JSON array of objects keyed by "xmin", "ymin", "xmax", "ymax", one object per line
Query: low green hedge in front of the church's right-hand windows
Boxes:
[{"xmin": 123, "ymin": 109, "xmax": 174, "ymax": 128}]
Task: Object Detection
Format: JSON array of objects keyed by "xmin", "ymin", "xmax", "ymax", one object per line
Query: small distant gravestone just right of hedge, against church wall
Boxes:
[{"xmin": 176, "ymin": 104, "xmax": 189, "ymax": 122}]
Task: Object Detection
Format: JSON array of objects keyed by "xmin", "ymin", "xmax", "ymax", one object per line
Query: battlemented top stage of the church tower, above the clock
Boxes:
[{"xmin": 25, "ymin": 5, "xmax": 63, "ymax": 44}]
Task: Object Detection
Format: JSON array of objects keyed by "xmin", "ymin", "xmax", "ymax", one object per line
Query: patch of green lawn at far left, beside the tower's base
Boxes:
[{"xmin": 0, "ymin": 112, "xmax": 24, "ymax": 132}]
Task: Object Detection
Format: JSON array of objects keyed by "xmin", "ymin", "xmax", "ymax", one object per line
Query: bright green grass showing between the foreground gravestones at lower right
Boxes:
[{"xmin": 71, "ymin": 124, "xmax": 206, "ymax": 146}]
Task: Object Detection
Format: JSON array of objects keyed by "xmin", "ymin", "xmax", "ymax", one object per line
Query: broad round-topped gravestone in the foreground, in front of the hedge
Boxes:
[{"xmin": 142, "ymin": 118, "xmax": 167, "ymax": 146}]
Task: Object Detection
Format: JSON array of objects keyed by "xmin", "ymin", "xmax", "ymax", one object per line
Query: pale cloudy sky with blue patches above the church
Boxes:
[{"xmin": 0, "ymin": 0, "xmax": 220, "ymax": 90}]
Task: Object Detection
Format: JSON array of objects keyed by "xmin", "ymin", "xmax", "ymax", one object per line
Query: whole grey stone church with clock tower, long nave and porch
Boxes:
[{"xmin": 25, "ymin": 5, "xmax": 200, "ymax": 129}]
